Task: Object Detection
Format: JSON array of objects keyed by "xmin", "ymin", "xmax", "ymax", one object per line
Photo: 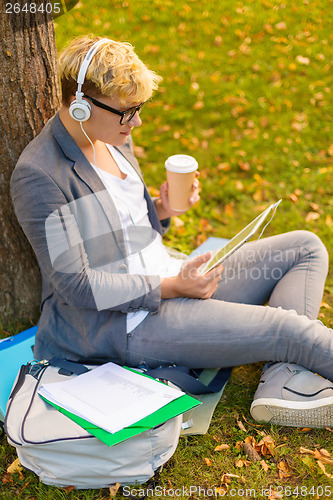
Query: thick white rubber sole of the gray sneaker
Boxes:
[{"xmin": 250, "ymin": 397, "xmax": 333, "ymax": 428}]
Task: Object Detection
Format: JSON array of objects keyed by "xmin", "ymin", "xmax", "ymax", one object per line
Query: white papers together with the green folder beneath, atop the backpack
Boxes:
[{"xmin": 38, "ymin": 363, "xmax": 200, "ymax": 446}]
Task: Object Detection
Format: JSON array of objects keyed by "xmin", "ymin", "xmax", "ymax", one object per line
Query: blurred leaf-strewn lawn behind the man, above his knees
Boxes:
[{"xmin": 55, "ymin": 0, "xmax": 333, "ymax": 296}]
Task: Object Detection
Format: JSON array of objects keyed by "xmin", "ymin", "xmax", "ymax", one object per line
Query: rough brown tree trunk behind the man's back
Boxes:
[{"xmin": 0, "ymin": 0, "xmax": 60, "ymax": 328}]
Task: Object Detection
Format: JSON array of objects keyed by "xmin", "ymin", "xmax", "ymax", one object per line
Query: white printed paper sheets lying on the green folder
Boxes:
[{"xmin": 38, "ymin": 363, "xmax": 184, "ymax": 433}]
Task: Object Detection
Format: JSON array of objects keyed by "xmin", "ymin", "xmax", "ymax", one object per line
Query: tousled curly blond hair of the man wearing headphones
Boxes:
[{"xmin": 59, "ymin": 35, "xmax": 162, "ymax": 106}]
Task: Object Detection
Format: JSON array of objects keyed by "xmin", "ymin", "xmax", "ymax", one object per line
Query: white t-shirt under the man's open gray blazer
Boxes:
[{"xmin": 91, "ymin": 145, "xmax": 183, "ymax": 333}]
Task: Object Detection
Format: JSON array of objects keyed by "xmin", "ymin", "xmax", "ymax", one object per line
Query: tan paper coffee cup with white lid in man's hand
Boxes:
[{"xmin": 165, "ymin": 155, "xmax": 198, "ymax": 212}]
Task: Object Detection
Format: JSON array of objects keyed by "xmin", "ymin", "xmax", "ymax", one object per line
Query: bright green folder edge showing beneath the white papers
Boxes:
[{"xmin": 41, "ymin": 367, "xmax": 201, "ymax": 446}]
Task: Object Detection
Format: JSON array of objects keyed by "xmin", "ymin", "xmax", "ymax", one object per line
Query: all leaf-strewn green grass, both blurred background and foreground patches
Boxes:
[{"xmin": 0, "ymin": 0, "xmax": 333, "ymax": 500}]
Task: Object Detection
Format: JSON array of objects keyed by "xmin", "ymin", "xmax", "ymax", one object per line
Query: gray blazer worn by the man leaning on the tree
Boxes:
[{"xmin": 11, "ymin": 114, "xmax": 169, "ymax": 364}]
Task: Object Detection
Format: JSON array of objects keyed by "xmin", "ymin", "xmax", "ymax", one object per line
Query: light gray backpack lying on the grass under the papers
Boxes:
[{"xmin": 5, "ymin": 362, "xmax": 182, "ymax": 488}]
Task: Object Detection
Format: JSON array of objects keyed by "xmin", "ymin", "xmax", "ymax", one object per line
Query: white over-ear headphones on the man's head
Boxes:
[{"xmin": 69, "ymin": 38, "xmax": 110, "ymax": 122}]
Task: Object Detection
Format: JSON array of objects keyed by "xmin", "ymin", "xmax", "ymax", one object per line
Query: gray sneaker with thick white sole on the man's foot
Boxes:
[{"xmin": 250, "ymin": 363, "xmax": 333, "ymax": 427}]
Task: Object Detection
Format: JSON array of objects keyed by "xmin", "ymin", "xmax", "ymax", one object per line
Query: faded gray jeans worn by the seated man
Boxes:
[{"xmin": 127, "ymin": 231, "xmax": 333, "ymax": 381}]
